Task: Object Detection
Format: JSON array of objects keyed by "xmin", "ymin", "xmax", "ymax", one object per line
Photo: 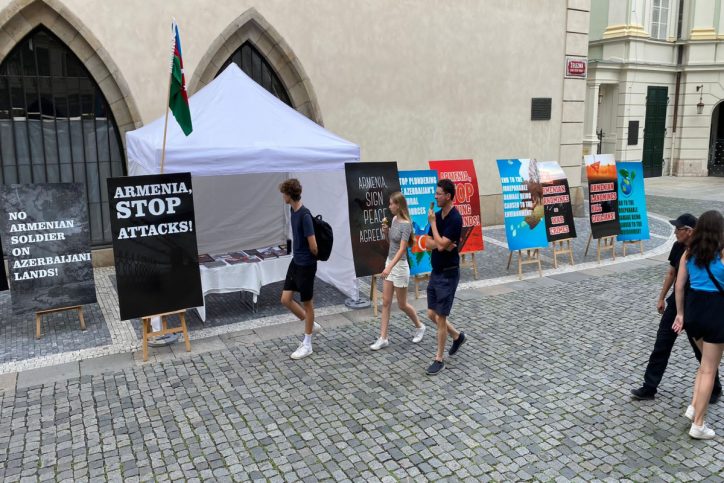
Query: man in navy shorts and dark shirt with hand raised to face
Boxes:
[{"xmin": 426, "ymin": 179, "xmax": 465, "ymax": 376}]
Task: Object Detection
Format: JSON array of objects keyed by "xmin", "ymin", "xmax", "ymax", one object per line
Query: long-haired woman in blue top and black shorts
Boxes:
[{"xmin": 672, "ymin": 210, "xmax": 724, "ymax": 439}]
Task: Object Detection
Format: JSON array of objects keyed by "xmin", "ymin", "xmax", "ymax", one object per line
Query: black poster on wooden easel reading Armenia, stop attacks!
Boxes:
[{"xmin": 108, "ymin": 173, "xmax": 203, "ymax": 320}]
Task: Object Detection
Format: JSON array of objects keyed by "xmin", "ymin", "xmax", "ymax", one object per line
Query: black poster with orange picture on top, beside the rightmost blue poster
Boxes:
[{"xmin": 583, "ymin": 154, "xmax": 621, "ymax": 239}]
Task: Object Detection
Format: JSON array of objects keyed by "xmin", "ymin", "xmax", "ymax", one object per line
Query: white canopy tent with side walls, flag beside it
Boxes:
[{"xmin": 126, "ymin": 63, "xmax": 360, "ymax": 298}]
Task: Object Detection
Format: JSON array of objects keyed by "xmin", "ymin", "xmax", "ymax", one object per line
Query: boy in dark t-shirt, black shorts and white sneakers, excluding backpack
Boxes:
[{"xmin": 279, "ymin": 178, "xmax": 321, "ymax": 359}]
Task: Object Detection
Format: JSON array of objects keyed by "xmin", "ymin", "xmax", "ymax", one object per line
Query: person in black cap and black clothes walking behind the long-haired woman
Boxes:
[{"xmin": 631, "ymin": 213, "xmax": 722, "ymax": 403}]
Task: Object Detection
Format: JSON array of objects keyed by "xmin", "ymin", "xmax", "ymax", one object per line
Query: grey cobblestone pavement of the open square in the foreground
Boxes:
[{"xmin": 0, "ymin": 261, "xmax": 724, "ymax": 482}]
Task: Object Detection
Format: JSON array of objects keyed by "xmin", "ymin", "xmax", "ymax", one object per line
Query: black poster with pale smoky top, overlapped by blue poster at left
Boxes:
[{"xmin": 538, "ymin": 161, "xmax": 576, "ymax": 242}]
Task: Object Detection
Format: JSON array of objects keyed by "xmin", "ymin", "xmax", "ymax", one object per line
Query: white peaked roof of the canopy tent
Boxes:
[{"xmin": 126, "ymin": 62, "xmax": 360, "ymax": 176}]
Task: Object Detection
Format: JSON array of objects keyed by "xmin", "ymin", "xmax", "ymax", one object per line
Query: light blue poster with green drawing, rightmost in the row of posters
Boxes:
[{"xmin": 616, "ymin": 161, "xmax": 651, "ymax": 241}]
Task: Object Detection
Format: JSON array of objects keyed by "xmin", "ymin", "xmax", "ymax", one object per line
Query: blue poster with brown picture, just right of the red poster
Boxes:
[{"xmin": 498, "ymin": 159, "xmax": 548, "ymax": 251}]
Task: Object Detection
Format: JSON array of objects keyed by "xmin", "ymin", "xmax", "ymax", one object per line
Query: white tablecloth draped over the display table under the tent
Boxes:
[{"xmin": 196, "ymin": 255, "xmax": 292, "ymax": 321}]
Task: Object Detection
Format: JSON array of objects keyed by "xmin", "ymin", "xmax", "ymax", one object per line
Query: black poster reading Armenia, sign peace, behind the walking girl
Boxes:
[{"xmin": 344, "ymin": 162, "xmax": 400, "ymax": 277}]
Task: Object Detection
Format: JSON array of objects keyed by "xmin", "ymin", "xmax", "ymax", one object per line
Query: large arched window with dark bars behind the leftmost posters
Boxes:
[{"xmin": 0, "ymin": 27, "xmax": 125, "ymax": 246}]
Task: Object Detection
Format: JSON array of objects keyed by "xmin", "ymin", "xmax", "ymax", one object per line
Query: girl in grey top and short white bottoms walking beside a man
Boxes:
[{"xmin": 370, "ymin": 191, "xmax": 425, "ymax": 351}]
